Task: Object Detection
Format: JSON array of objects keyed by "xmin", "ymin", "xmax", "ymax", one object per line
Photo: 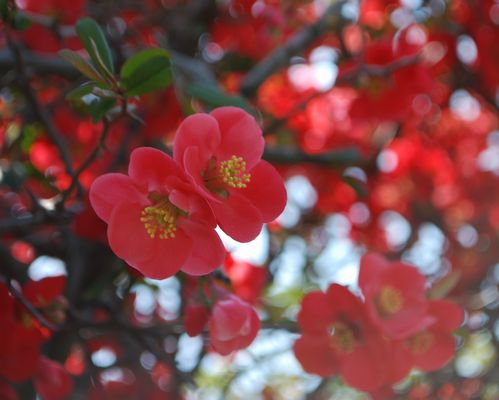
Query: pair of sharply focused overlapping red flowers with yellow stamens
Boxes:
[{"xmin": 90, "ymin": 107, "xmax": 286, "ymax": 279}]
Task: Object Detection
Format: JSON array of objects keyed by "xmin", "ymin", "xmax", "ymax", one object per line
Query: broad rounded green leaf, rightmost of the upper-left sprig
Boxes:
[{"xmin": 120, "ymin": 48, "xmax": 172, "ymax": 96}]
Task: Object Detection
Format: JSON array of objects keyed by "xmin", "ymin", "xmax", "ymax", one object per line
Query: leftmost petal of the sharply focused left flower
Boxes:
[{"xmin": 89, "ymin": 173, "xmax": 146, "ymax": 222}]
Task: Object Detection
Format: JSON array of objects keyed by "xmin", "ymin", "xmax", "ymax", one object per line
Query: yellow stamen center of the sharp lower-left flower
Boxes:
[{"xmin": 140, "ymin": 193, "xmax": 179, "ymax": 239}]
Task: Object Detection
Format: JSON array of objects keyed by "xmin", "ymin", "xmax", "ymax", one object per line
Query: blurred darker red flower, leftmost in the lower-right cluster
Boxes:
[{"xmin": 294, "ymin": 284, "xmax": 390, "ymax": 391}]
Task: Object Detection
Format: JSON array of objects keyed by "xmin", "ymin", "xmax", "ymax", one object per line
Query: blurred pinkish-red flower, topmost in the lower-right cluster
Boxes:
[{"xmin": 359, "ymin": 253, "xmax": 434, "ymax": 339}]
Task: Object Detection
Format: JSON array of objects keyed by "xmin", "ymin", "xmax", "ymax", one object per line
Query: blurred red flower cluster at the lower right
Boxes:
[{"xmin": 294, "ymin": 254, "xmax": 463, "ymax": 392}]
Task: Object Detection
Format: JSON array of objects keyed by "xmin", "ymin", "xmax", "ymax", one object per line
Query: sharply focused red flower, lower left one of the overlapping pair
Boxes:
[{"xmin": 90, "ymin": 147, "xmax": 225, "ymax": 279}]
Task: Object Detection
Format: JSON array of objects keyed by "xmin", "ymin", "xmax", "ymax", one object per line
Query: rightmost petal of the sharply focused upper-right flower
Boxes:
[{"xmin": 241, "ymin": 160, "xmax": 287, "ymax": 222}]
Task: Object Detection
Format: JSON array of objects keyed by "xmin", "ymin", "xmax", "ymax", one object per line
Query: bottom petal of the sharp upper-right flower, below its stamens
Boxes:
[{"xmin": 210, "ymin": 192, "xmax": 263, "ymax": 242}]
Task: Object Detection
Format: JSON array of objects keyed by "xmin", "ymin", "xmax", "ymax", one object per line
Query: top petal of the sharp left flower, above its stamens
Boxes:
[{"xmin": 128, "ymin": 147, "xmax": 183, "ymax": 192}]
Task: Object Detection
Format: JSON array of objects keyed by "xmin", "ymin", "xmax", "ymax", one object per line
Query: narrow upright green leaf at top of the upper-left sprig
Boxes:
[{"xmin": 76, "ymin": 18, "xmax": 114, "ymax": 75}]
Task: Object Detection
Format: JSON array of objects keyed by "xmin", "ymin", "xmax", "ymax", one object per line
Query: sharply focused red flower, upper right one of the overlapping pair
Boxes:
[{"xmin": 173, "ymin": 107, "xmax": 286, "ymax": 242}]
